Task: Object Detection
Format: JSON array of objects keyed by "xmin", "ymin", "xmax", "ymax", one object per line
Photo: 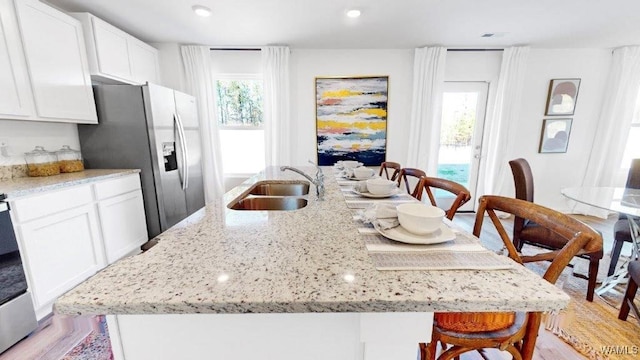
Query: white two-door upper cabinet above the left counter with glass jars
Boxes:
[{"xmin": 0, "ymin": 0, "xmax": 98, "ymax": 124}]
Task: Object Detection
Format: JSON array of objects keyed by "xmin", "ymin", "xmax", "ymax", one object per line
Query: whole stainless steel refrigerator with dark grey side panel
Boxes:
[{"xmin": 78, "ymin": 84, "xmax": 204, "ymax": 239}]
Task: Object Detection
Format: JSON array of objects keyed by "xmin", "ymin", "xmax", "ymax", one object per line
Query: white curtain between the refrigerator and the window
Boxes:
[{"xmin": 180, "ymin": 46, "xmax": 224, "ymax": 203}]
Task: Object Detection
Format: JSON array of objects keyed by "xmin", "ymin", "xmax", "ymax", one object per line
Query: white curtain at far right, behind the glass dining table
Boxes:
[{"xmin": 574, "ymin": 46, "xmax": 640, "ymax": 217}]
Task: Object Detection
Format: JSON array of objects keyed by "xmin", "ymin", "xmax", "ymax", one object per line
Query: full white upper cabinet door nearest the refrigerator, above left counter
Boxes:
[{"xmin": 16, "ymin": 0, "xmax": 97, "ymax": 123}]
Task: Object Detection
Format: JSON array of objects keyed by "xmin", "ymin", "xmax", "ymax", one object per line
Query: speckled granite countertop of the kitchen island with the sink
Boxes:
[{"xmin": 55, "ymin": 168, "xmax": 569, "ymax": 314}]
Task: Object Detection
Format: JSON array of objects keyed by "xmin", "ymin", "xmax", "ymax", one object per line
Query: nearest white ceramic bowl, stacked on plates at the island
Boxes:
[{"xmin": 396, "ymin": 203, "xmax": 444, "ymax": 235}]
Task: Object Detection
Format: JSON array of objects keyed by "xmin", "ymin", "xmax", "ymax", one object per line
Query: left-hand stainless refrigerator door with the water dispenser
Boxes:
[{"xmin": 143, "ymin": 84, "xmax": 188, "ymax": 231}]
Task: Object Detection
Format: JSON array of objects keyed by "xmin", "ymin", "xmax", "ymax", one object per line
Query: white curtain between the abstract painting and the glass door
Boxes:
[{"xmin": 407, "ymin": 47, "xmax": 447, "ymax": 176}]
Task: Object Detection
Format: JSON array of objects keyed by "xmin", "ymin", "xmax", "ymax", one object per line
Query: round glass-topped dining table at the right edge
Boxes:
[{"xmin": 561, "ymin": 187, "xmax": 640, "ymax": 295}]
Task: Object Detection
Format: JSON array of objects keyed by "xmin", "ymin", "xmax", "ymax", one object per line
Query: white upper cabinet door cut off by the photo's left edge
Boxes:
[{"xmin": 0, "ymin": 0, "xmax": 34, "ymax": 118}]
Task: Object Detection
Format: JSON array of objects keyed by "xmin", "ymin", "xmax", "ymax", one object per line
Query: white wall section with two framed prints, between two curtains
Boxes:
[{"xmin": 505, "ymin": 49, "xmax": 611, "ymax": 211}]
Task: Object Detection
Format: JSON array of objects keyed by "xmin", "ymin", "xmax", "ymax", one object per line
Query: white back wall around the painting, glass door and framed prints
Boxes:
[{"xmin": 154, "ymin": 44, "xmax": 611, "ymax": 211}]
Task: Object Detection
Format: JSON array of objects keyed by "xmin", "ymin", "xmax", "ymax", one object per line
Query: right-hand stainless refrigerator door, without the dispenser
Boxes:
[{"xmin": 175, "ymin": 91, "xmax": 204, "ymax": 215}]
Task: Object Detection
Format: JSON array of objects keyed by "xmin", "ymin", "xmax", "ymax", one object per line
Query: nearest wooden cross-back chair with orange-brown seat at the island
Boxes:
[{"xmin": 420, "ymin": 195, "xmax": 602, "ymax": 360}]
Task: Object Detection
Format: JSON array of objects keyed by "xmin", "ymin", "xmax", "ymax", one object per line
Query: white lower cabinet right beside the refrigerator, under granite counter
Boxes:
[{"xmin": 95, "ymin": 174, "xmax": 148, "ymax": 264}]
